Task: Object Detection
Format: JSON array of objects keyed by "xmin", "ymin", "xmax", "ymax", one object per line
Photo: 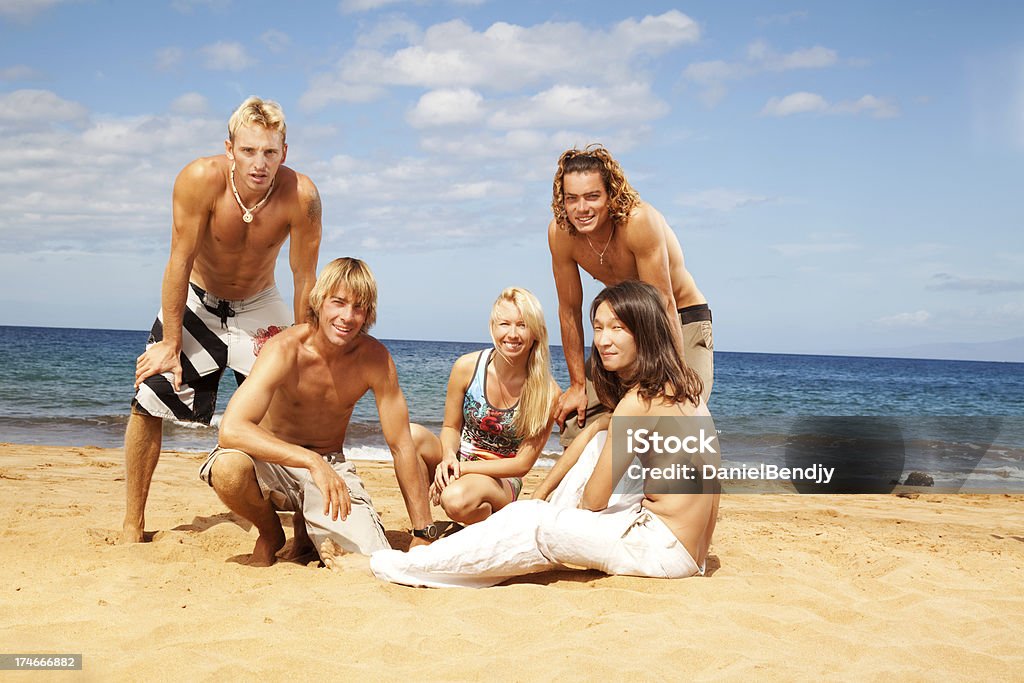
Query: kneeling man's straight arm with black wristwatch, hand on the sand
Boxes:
[{"xmin": 370, "ymin": 346, "xmax": 432, "ymax": 532}]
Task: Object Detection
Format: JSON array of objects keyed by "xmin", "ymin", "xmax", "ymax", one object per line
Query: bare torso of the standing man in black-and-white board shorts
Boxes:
[{"xmin": 174, "ymin": 156, "xmax": 311, "ymax": 299}]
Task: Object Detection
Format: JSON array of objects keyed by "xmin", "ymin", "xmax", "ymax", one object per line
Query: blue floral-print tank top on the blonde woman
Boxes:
[{"xmin": 459, "ymin": 349, "xmax": 522, "ymax": 460}]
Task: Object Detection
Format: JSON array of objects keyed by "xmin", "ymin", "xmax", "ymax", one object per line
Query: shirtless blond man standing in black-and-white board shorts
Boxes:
[{"xmin": 123, "ymin": 97, "xmax": 321, "ymax": 543}]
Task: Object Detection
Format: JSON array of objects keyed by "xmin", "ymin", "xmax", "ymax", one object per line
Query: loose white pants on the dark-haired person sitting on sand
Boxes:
[{"xmin": 370, "ymin": 432, "xmax": 700, "ymax": 588}]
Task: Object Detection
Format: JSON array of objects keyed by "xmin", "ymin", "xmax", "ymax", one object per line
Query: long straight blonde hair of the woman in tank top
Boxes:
[{"xmin": 490, "ymin": 287, "xmax": 556, "ymax": 438}]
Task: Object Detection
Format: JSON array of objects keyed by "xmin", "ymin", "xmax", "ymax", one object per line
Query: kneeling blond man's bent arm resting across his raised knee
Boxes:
[{"xmin": 218, "ymin": 338, "xmax": 351, "ymax": 519}]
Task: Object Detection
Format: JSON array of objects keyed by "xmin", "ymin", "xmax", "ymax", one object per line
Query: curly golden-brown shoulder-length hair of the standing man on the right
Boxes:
[{"xmin": 551, "ymin": 142, "xmax": 640, "ymax": 237}]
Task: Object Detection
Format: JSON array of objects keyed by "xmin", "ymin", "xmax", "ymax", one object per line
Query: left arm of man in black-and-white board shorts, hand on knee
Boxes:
[{"xmin": 135, "ymin": 159, "xmax": 220, "ymax": 389}]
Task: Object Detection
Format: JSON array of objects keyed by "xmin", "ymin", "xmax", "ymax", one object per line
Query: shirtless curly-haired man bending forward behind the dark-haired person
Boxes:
[{"xmin": 548, "ymin": 145, "xmax": 715, "ymax": 446}]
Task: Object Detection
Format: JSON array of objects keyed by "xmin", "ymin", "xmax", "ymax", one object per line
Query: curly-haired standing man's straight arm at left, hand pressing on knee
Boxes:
[{"xmin": 548, "ymin": 221, "xmax": 587, "ymax": 427}]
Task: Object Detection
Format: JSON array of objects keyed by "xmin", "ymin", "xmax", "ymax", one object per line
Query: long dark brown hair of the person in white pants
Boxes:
[{"xmin": 590, "ymin": 280, "xmax": 703, "ymax": 408}]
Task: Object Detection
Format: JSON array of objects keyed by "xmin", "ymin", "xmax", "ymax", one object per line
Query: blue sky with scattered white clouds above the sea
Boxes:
[{"xmin": 0, "ymin": 0, "xmax": 1024, "ymax": 354}]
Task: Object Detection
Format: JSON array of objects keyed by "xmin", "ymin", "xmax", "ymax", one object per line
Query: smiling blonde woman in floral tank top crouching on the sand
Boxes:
[{"xmin": 412, "ymin": 287, "xmax": 559, "ymax": 524}]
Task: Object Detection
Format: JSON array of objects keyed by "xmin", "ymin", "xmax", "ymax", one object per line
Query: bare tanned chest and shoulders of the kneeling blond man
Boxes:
[{"xmin": 256, "ymin": 324, "xmax": 390, "ymax": 454}]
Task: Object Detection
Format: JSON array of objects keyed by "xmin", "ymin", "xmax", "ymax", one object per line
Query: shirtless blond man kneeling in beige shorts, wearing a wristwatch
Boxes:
[{"xmin": 200, "ymin": 258, "xmax": 437, "ymax": 566}]
